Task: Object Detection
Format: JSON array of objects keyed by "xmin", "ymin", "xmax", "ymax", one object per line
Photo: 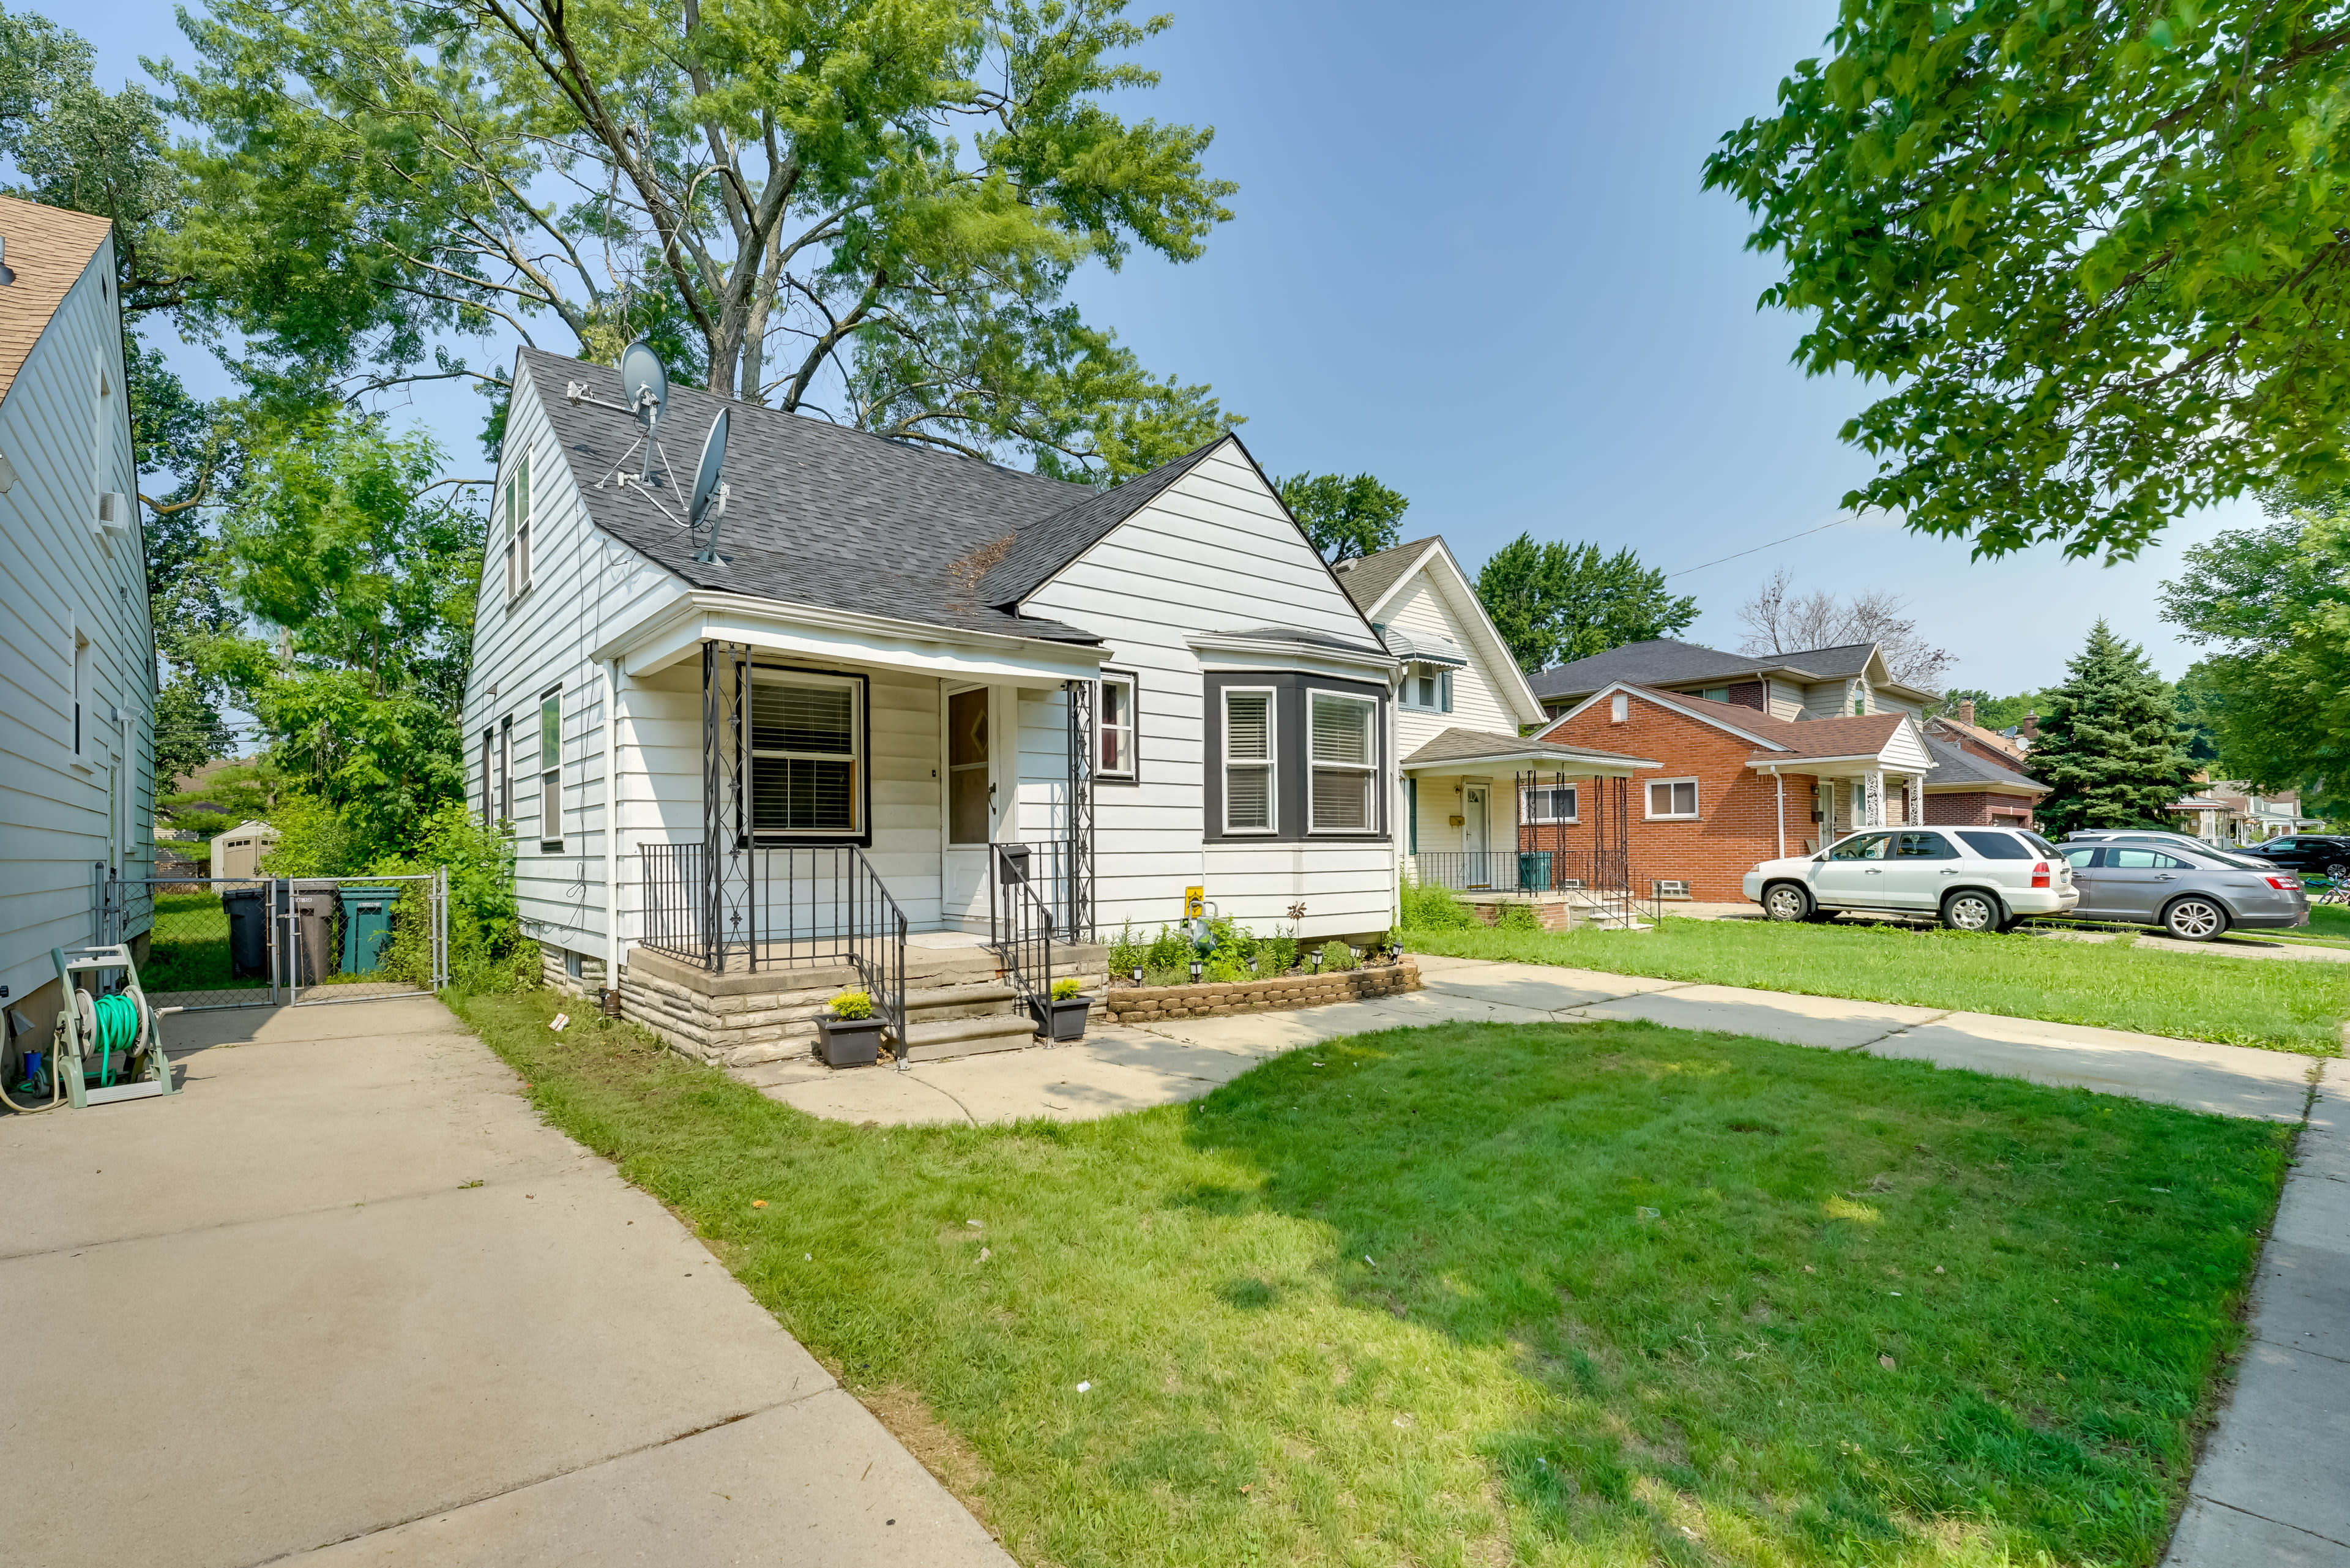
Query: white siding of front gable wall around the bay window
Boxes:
[{"xmin": 1020, "ymin": 444, "xmax": 1398, "ymax": 936}]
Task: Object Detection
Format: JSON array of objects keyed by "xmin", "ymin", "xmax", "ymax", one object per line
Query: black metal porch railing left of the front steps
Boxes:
[{"xmin": 637, "ymin": 844, "xmax": 907, "ymax": 1067}]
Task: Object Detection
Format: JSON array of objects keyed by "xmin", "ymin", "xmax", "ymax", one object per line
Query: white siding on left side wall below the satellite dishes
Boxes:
[{"xmin": 465, "ymin": 364, "xmax": 703, "ymax": 959}]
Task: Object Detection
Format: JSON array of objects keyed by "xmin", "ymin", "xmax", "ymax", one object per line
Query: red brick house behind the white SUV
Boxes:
[{"xmin": 1539, "ymin": 682, "xmax": 1945, "ymax": 903}]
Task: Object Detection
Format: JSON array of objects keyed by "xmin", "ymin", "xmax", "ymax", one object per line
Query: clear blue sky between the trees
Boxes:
[{"xmin": 50, "ymin": 0, "xmax": 2256, "ymax": 691}]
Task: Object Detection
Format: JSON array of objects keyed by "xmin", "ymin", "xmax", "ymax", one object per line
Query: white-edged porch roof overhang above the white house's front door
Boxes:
[{"xmin": 595, "ymin": 592, "xmax": 1109, "ymax": 687}]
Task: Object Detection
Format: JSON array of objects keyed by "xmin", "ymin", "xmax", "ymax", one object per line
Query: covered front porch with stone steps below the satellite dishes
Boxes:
[{"xmin": 613, "ymin": 637, "xmax": 1107, "ymax": 1067}]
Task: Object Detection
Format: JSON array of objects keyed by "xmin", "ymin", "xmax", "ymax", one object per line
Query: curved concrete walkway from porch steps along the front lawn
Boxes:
[{"xmin": 736, "ymin": 957, "xmax": 2313, "ymax": 1126}]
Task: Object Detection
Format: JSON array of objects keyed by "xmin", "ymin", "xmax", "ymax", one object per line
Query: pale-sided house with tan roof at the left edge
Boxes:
[{"xmin": 0, "ymin": 198, "xmax": 155, "ymax": 1029}]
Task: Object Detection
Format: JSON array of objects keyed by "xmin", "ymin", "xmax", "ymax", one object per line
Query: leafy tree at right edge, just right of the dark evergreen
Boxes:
[{"xmin": 2162, "ymin": 494, "xmax": 2350, "ymax": 799}]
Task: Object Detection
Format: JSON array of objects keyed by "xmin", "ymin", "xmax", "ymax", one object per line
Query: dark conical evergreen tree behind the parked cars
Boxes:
[{"xmin": 2031, "ymin": 621, "xmax": 2195, "ymax": 835}]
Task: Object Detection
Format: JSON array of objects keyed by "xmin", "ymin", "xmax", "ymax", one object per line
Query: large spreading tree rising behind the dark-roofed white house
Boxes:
[{"xmin": 169, "ymin": 0, "xmax": 1231, "ymax": 477}]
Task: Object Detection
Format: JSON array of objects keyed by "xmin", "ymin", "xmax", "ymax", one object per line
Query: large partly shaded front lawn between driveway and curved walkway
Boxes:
[{"xmin": 458, "ymin": 995, "xmax": 2291, "ymax": 1568}]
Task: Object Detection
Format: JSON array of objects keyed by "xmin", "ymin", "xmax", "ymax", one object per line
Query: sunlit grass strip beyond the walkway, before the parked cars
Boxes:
[{"xmin": 1403, "ymin": 917, "xmax": 2350, "ymax": 1056}]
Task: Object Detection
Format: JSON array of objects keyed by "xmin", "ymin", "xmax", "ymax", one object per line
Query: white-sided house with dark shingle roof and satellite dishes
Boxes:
[{"xmin": 465, "ymin": 350, "xmax": 1539, "ymax": 1058}]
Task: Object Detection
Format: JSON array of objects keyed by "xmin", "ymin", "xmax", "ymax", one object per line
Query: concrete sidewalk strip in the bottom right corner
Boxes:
[{"xmin": 2162, "ymin": 1060, "xmax": 2350, "ymax": 1568}]
